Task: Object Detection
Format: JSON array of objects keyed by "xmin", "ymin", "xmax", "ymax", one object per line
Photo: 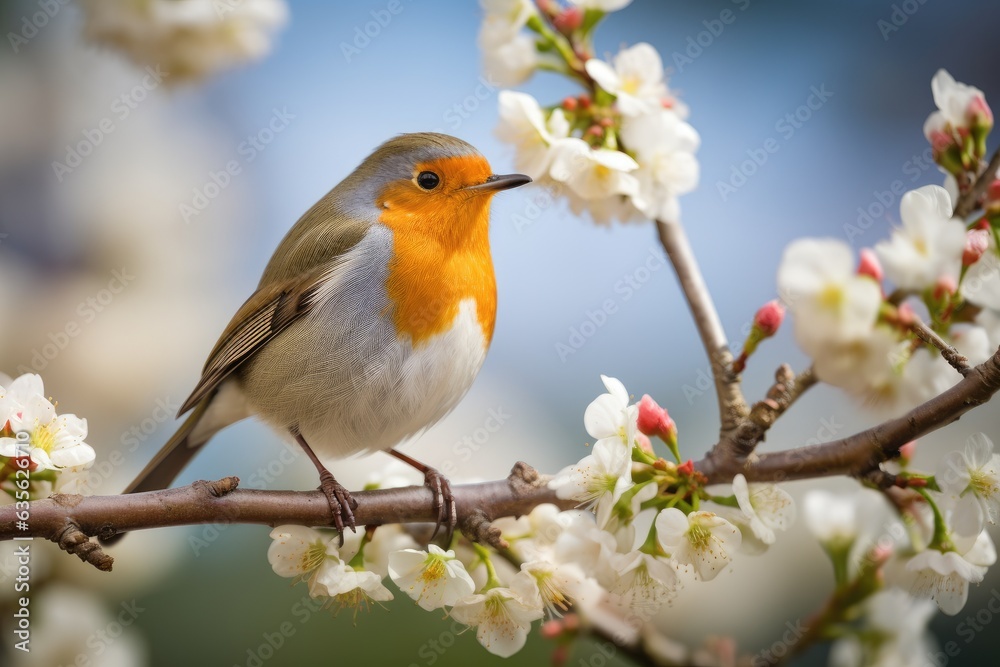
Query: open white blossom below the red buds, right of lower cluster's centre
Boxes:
[{"xmin": 656, "ymin": 507, "xmax": 742, "ymax": 581}]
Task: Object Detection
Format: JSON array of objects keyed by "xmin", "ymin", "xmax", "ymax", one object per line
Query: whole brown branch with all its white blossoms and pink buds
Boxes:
[{"xmin": 0, "ymin": 0, "xmax": 1000, "ymax": 664}]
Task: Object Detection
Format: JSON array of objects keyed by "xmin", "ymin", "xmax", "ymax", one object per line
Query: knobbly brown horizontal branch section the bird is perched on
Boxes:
[{"xmin": 0, "ymin": 463, "xmax": 577, "ymax": 570}]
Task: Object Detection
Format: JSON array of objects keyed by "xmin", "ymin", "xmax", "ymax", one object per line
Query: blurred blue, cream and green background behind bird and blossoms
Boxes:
[{"xmin": 0, "ymin": 0, "xmax": 1000, "ymax": 667}]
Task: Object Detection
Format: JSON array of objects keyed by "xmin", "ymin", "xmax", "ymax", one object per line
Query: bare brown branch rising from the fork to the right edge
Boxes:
[{"xmin": 695, "ymin": 349, "xmax": 1000, "ymax": 483}]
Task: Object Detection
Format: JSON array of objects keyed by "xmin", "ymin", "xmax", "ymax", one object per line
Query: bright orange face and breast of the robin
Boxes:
[{"xmin": 379, "ymin": 157, "xmax": 497, "ymax": 347}]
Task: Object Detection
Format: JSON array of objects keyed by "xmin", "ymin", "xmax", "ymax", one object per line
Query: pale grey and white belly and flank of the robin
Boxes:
[{"xmin": 240, "ymin": 230, "xmax": 487, "ymax": 462}]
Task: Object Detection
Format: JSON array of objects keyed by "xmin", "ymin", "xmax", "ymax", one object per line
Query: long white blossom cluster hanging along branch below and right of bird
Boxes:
[{"xmin": 268, "ymin": 377, "xmax": 795, "ymax": 656}]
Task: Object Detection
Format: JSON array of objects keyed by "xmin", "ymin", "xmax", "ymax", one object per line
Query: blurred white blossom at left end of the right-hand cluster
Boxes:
[{"xmin": 778, "ymin": 239, "xmax": 882, "ymax": 356}]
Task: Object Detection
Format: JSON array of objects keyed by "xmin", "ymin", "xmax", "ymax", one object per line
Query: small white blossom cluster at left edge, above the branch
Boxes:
[{"xmin": 0, "ymin": 373, "xmax": 95, "ymax": 504}]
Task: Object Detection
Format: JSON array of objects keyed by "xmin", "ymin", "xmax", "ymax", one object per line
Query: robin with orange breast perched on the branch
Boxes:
[{"xmin": 105, "ymin": 133, "xmax": 531, "ymax": 543}]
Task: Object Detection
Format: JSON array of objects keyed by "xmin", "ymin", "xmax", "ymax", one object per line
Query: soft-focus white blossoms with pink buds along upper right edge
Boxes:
[{"xmin": 778, "ymin": 70, "xmax": 1000, "ymax": 412}]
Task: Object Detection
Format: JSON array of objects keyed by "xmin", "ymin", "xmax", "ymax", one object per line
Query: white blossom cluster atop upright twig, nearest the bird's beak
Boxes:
[{"xmin": 480, "ymin": 0, "xmax": 701, "ymax": 222}]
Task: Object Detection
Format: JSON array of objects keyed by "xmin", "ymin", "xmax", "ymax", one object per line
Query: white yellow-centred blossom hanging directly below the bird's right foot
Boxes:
[{"xmin": 389, "ymin": 544, "xmax": 476, "ymax": 611}]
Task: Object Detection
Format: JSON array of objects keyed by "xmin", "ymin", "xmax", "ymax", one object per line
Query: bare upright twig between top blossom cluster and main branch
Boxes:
[{"xmin": 656, "ymin": 220, "xmax": 747, "ymax": 437}]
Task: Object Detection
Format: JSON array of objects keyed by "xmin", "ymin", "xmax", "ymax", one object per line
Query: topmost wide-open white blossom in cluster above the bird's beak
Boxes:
[{"xmin": 586, "ymin": 42, "xmax": 667, "ymax": 116}]
